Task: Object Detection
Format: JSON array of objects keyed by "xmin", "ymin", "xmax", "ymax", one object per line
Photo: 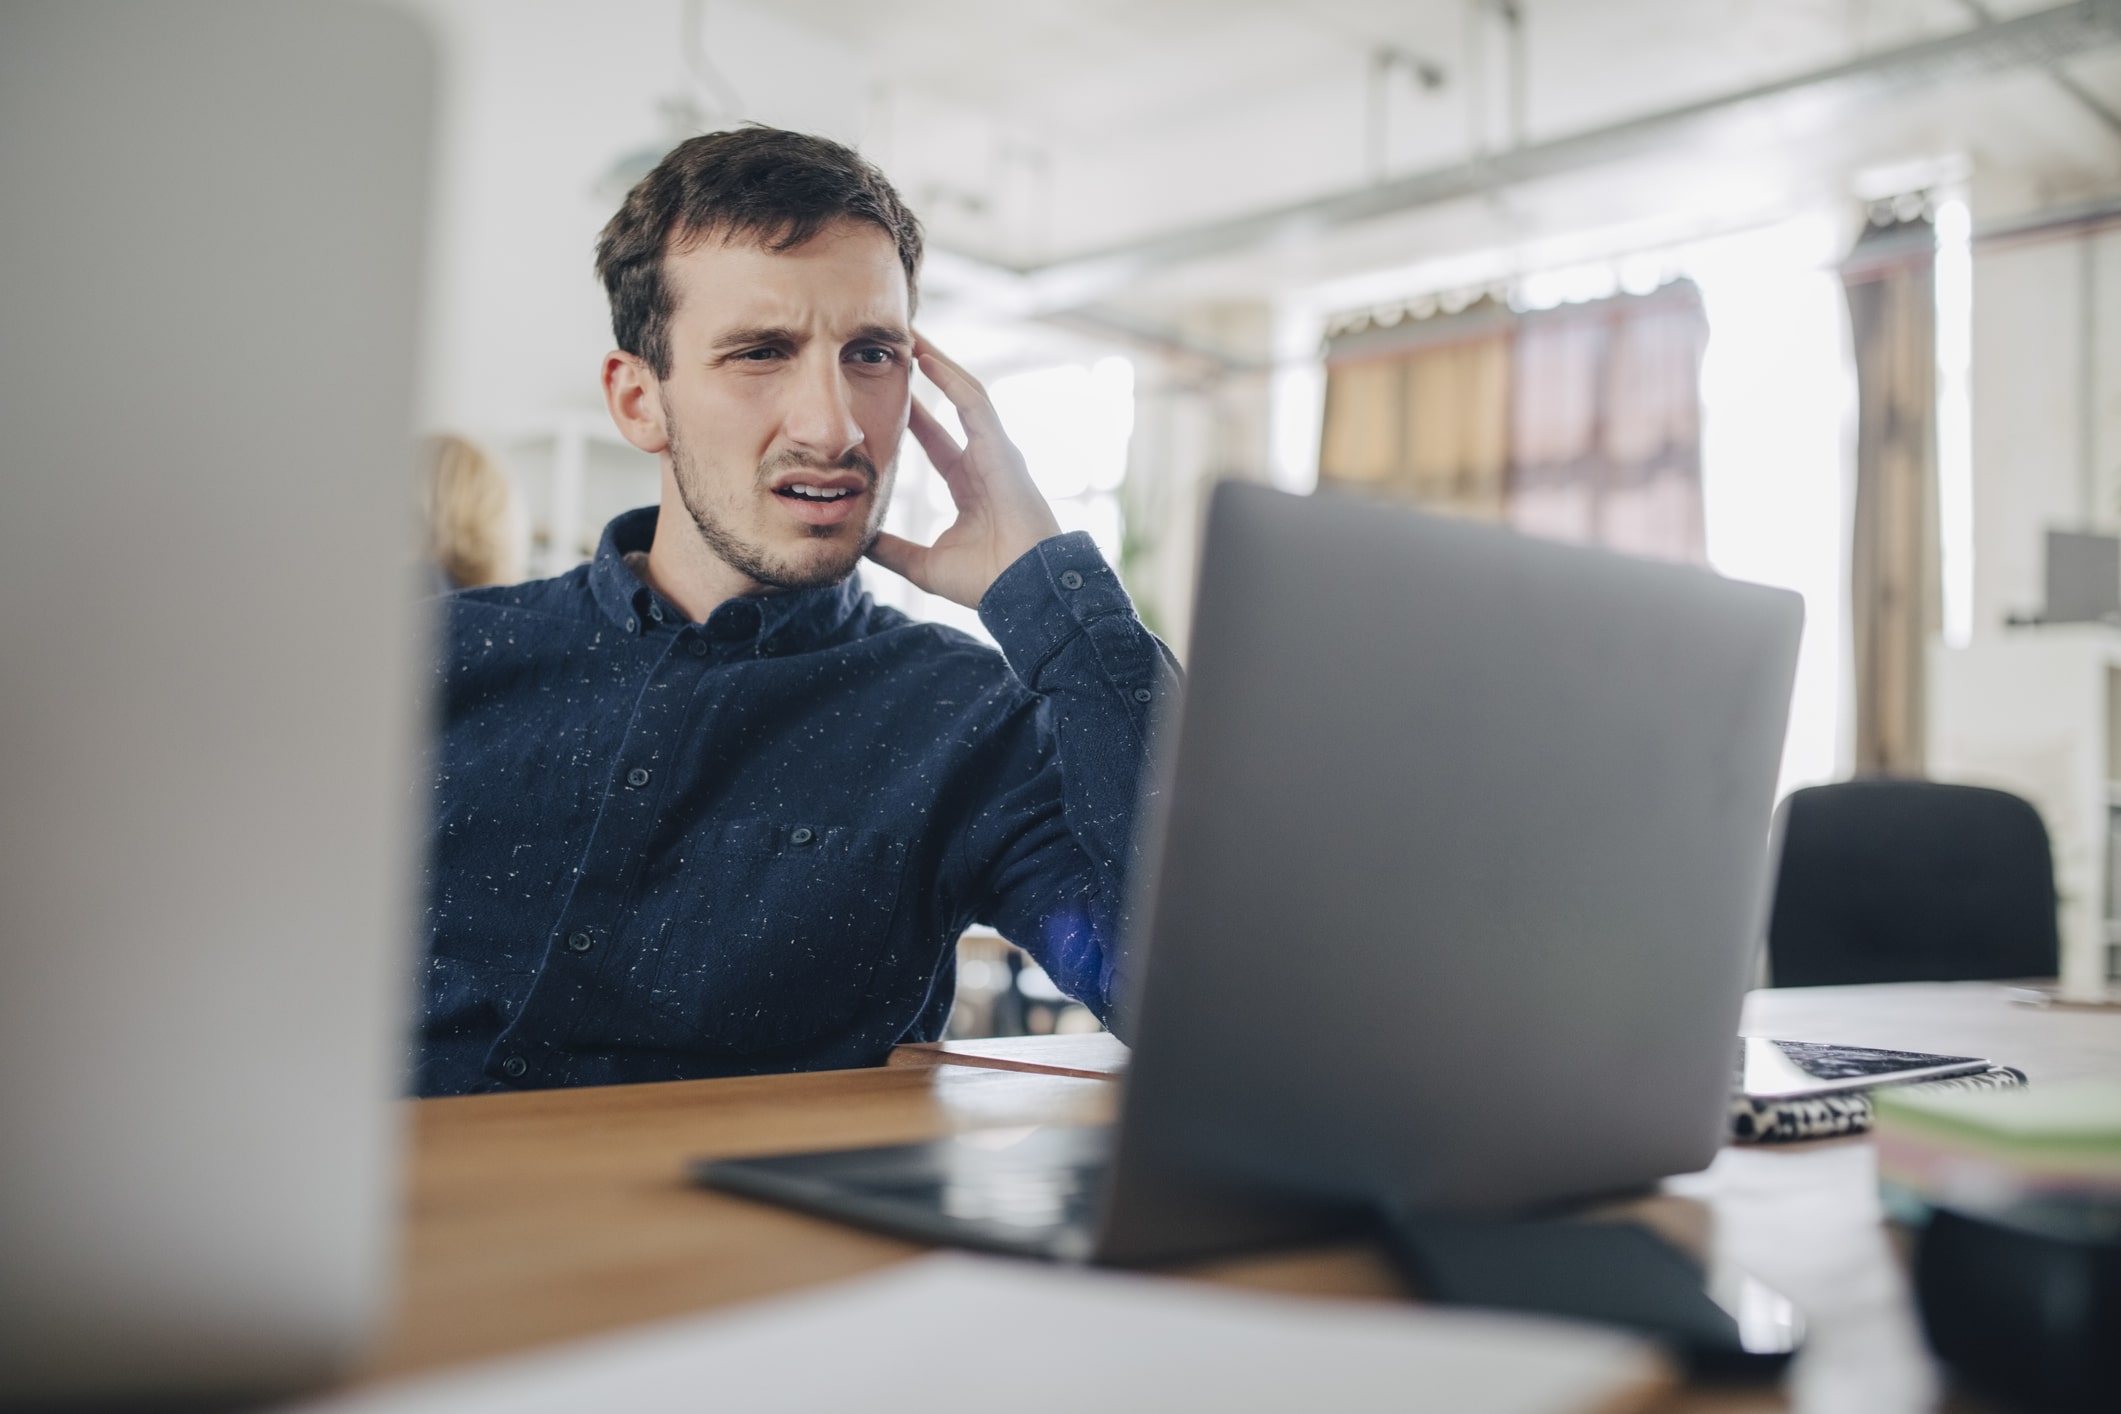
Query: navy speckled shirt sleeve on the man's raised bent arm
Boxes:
[{"xmin": 980, "ymin": 532, "xmax": 1179, "ymax": 1022}]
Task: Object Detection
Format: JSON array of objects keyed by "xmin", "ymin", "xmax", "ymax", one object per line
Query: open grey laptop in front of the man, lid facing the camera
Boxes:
[{"xmin": 698, "ymin": 483, "xmax": 1803, "ymax": 1263}]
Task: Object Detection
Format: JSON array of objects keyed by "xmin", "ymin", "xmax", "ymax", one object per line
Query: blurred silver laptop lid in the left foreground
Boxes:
[{"xmin": 0, "ymin": 0, "xmax": 433, "ymax": 1408}]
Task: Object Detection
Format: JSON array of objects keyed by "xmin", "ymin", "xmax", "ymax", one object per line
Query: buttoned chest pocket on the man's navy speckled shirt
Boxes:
[{"xmin": 653, "ymin": 820, "xmax": 906, "ymax": 1054}]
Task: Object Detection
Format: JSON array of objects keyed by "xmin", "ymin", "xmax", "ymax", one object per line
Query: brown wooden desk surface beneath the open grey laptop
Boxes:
[{"xmin": 371, "ymin": 984, "xmax": 2121, "ymax": 1414}]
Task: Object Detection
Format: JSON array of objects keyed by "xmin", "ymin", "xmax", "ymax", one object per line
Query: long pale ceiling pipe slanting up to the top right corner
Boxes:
[{"xmin": 931, "ymin": 0, "xmax": 2121, "ymax": 316}]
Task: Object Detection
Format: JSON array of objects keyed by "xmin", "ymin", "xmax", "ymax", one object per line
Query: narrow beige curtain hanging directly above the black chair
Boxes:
[{"xmin": 1841, "ymin": 218, "xmax": 1941, "ymax": 776}]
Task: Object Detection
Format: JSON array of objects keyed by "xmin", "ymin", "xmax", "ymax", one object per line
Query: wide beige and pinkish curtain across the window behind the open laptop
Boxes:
[{"xmin": 1319, "ymin": 282, "xmax": 1707, "ymax": 562}]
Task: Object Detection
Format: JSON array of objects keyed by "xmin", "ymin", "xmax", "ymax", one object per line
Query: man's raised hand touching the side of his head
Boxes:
[{"xmin": 870, "ymin": 335, "xmax": 1061, "ymax": 608}]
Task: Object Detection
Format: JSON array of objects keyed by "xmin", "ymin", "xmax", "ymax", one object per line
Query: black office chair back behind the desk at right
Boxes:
[{"xmin": 1767, "ymin": 780, "xmax": 2059, "ymax": 988}]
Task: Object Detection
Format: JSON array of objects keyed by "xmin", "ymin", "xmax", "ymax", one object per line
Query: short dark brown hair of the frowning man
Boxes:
[{"xmin": 596, "ymin": 125, "xmax": 921, "ymax": 377}]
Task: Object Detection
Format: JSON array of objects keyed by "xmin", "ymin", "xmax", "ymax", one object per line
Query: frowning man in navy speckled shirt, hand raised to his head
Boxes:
[{"xmin": 416, "ymin": 127, "xmax": 1175, "ymax": 1094}]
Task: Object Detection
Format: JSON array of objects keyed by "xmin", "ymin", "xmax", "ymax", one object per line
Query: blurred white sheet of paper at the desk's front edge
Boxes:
[{"xmin": 301, "ymin": 1253, "xmax": 1663, "ymax": 1414}]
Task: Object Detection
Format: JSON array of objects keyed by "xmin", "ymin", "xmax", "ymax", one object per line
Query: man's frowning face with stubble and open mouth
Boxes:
[{"xmin": 660, "ymin": 220, "xmax": 914, "ymax": 589}]
